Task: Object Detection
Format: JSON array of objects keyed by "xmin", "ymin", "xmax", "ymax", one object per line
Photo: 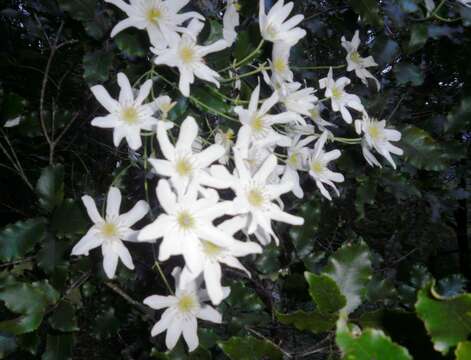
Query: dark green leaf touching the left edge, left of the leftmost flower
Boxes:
[{"xmin": 0, "ymin": 218, "xmax": 46, "ymax": 261}]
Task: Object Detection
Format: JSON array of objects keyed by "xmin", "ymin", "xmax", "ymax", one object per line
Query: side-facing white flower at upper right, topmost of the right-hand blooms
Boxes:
[{"xmin": 342, "ymin": 30, "xmax": 381, "ymax": 91}]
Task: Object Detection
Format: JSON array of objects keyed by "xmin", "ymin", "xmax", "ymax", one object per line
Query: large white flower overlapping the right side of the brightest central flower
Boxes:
[{"xmin": 211, "ymin": 149, "xmax": 304, "ymax": 243}]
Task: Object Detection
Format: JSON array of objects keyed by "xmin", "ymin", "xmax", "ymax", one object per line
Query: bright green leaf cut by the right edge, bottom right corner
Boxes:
[{"xmin": 415, "ymin": 282, "xmax": 471, "ymax": 354}]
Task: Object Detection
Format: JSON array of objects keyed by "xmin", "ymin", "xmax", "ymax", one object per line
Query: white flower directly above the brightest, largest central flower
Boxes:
[{"xmin": 149, "ymin": 116, "xmax": 225, "ymax": 192}]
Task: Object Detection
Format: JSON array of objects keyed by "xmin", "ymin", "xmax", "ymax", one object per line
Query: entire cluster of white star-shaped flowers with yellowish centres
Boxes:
[{"xmin": 72, "ymin": 0, "xmax": 402, "ymax": 351}]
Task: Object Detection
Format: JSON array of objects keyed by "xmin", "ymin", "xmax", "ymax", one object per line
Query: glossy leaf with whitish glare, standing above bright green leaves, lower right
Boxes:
[{"xmin": 324, "ymin": 241, "xmax": 372, "ymax": 313}]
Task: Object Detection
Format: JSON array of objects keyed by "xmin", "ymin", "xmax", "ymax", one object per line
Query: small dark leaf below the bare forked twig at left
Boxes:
[{"xmin": 36, "ymin": 165, "xmax": 64, "ymax": 212}]
